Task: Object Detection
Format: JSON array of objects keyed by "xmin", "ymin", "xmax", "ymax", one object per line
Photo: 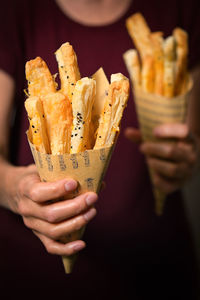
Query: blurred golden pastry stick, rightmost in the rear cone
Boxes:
[{"xmin": 173, "ymin": 27, "xmax": 188, "ymax": 95}]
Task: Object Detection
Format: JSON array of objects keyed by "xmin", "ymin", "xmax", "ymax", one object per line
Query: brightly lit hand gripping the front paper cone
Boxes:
[{"xmin": 6, "ymin": 165, "xmax": 97, "ymax": 256}]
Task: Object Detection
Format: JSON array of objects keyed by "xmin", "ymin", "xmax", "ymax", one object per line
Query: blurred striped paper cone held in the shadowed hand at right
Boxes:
[{"xmin": 133, "ymin": 80, "xmax": 192, "ymax": 215}]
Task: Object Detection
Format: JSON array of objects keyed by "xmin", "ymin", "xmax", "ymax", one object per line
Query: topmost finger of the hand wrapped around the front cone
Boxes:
[{"xmin": 19, "ymin": 174, "xmax": 77, "ymax": 202}]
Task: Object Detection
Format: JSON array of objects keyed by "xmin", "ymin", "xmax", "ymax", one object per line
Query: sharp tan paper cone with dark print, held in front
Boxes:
[{"xmin": 27, "ymin": 132, "xmax": 114, "ymax": 273}]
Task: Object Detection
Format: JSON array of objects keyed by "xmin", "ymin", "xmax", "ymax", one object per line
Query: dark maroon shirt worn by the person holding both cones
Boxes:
[{"xmin": 0, "ymin": 0, "xmax": 200, "ymax": 299}]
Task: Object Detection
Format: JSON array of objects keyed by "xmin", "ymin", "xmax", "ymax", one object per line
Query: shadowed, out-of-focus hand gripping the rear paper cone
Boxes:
[{"xmin": 125, "ymin": 124, "xmax": 197, "ymax": 194}]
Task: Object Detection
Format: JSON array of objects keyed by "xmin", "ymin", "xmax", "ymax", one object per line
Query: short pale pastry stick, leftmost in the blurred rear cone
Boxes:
[{"xmin": 123, "ymin": 49, "xmax": 141, "ymax": 88}]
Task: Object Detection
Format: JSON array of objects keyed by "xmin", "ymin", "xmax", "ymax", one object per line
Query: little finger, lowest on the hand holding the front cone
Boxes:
[{"xmin": 34, "ymin": 231, "xmax": 86, "ymax": 256}]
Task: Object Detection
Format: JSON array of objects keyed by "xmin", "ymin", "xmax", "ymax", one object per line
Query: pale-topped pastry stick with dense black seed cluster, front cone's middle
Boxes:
[{"xmin": 70, "ymin": 77, "xmax": 96, "ymax": 153}]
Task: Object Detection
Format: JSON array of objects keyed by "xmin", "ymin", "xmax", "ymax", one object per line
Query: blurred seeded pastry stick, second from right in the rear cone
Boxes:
[{"xmin": 163, "ymin": 36, "xmax": 176, "ymax": 97}]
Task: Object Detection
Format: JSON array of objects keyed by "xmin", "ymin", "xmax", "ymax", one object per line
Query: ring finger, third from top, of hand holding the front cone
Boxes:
[{"xmin": 23, "ymin": 207, "xmax": 96, "ymax": 240}]
